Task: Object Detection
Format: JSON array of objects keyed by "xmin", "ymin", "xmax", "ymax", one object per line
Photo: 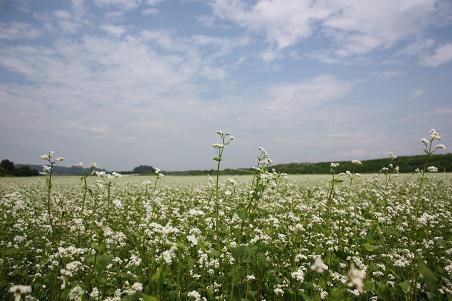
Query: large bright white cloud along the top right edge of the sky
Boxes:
[{"xmin": 213, "ymin": 0, "xmax": 452, "ymax": 57}]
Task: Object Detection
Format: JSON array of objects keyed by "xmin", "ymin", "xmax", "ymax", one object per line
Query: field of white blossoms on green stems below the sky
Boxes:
[{"xmin": 0, "ymin": 130, "xmax": 452, "ymax": 301}]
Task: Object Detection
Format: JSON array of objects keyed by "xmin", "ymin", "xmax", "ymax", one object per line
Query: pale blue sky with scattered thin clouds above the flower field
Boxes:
[{"xmin": 0, "ymin": 0, "xmax": 452, "ymax": 170}]
